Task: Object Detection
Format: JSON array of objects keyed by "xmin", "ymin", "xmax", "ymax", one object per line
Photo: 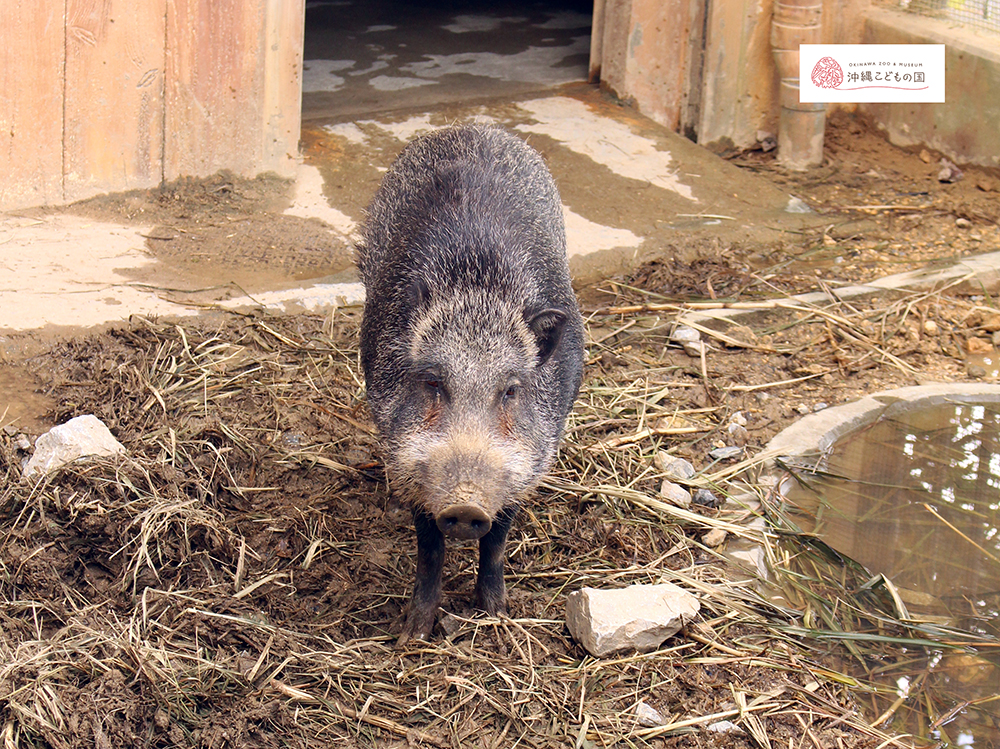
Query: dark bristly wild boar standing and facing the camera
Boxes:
[{"xmin": 357, "ymin": 125, "xmax": 583, "ymax": 636}]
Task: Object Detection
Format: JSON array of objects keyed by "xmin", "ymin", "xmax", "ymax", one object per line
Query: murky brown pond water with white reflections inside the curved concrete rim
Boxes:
[{"xmin": 786, "ymin": 403, "xmax": 1000, "ymax": 746}]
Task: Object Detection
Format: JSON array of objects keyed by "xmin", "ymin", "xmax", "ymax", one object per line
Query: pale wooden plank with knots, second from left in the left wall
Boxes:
[{"xmin": 63, "ymin": 0, "xmax": 166, "ymax": 201}]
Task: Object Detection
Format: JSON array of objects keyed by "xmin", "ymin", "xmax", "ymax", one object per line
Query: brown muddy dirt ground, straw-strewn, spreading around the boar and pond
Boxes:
[{"xmin": 0, "ymin": 115, "xmax": 1000, "ymax": 749}]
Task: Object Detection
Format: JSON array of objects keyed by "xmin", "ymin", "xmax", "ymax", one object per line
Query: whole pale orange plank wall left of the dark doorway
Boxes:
[{"xmin": 0, "ymin": 0, "xmax": 305, "ymax": 209}]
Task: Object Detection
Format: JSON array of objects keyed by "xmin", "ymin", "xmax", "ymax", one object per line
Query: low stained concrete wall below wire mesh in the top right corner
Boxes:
[{"xmin": 859, "ymin": 9, "xmax": 1000, "ymax": 167}]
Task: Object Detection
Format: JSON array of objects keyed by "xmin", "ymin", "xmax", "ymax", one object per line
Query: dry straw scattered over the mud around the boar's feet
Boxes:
[{"xmin": 0, "ymin": 280, "xmax": 984, "ymax": 749}]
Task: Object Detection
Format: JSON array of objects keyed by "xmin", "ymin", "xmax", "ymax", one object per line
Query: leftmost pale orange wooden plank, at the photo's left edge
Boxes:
[{"xmin": 0, "ymin": 0, "xmax": 66, "ymax": 209}]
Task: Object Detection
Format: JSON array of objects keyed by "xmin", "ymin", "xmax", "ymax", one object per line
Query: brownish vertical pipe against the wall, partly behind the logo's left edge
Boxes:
[{"xmin": 771, "ymin": 0, "xmax": 826, "ymax": 171}]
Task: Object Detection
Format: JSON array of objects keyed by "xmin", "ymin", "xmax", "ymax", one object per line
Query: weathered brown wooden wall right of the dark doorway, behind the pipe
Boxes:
[{"xmin": 590, "ymin": 0, "xmax": 870, "ymax": 147}]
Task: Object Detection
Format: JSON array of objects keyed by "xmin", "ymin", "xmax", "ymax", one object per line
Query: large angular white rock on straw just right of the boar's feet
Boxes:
[{"xmin": 566, "ymin": 583, "xmax": 700, "ymax": 658}]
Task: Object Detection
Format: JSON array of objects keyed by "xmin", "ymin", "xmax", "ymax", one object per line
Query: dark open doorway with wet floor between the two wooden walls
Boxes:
[{"xmin": 302, "ymin": 0, "xmax": 592, "ymax": 121}]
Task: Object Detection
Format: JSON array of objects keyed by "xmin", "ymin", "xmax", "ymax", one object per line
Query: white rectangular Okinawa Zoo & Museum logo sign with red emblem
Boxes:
[{"xmin": 799, "ymin": 44, "xmax": 944, "ymax": 103}]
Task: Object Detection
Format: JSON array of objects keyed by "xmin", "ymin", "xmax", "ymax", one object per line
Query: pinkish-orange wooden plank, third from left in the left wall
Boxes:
[{"xmin": 164, "ymin": 0, "xmax": 265, "ymax": 181}]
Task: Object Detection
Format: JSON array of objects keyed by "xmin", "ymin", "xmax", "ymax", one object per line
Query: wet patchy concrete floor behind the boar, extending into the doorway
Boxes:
[{"xmin": 0, "ymin": 0, "xmax": 817, "ymax": 331}]
